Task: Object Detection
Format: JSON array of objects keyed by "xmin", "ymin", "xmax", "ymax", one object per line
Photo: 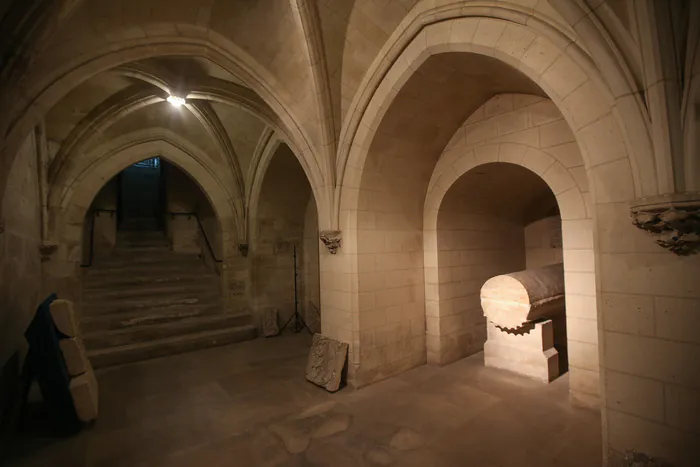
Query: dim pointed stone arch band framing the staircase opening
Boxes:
[{"xmin": 44, "ymin": 130, "xmax": 247, "ymax": 316}]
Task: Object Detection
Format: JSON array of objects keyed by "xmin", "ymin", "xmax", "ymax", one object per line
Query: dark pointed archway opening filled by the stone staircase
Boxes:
[{"xmin": 81, "ymin": 158, "xmax": 255, "ymax": 368}]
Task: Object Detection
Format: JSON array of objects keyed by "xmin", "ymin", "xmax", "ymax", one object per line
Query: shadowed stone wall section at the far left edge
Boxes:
[{"xmin": 0, "ymin": 133, "xmax": 42, "ymax": 425}]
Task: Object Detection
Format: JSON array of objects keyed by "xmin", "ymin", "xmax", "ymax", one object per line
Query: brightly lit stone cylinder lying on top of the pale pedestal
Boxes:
[{"xmin": 481, "ymin": 263, "xmax": 564, "ymax": 329}]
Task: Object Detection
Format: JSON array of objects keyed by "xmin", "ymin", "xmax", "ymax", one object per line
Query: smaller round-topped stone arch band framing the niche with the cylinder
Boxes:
[{"xmin": 423, "ymin": 143, "xmax": 597, "ymax": 374}]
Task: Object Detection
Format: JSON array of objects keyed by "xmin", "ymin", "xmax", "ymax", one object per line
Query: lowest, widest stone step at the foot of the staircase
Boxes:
[{"xmin": 87, "ymin": 325, "xmax": 257, "ymax": 368}]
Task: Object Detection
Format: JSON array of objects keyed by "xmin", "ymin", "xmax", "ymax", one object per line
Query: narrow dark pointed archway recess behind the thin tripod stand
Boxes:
[{"xmin": 250, "ymin": 144, "xmax": 321, "ymax": 332}]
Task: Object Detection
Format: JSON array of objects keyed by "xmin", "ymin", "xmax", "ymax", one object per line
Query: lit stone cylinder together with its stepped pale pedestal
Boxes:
[{"xmin": 481, "ymin": 263, "xmax": 566, "ymax": 382}]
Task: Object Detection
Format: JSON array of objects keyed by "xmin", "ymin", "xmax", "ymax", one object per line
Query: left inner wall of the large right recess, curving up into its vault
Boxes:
[{"xmin": 348, "ymin": 52, "xmax": 544, "ymax": 386}]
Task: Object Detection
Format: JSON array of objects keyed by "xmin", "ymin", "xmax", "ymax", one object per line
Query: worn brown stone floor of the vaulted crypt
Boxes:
[{"xmin": 0, "ymin": 336, "xmax": 601, "ymax": 467}]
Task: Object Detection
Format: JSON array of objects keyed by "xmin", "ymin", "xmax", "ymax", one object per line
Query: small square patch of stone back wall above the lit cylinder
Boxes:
[{"xmin": 525, "ymin": 216, "xmax": 564, "ymax": 269}]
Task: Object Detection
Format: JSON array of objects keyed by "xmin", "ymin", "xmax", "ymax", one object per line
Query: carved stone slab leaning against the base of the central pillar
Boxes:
[{"xmin": 306, "ymin": 334, "xmax": 348, "ymax": 392}]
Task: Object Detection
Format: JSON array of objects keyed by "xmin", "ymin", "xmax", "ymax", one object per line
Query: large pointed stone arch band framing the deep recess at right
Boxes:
[{"xmin": 336, "ymin": 6, "xmax": 669, "ymax": 225}]
